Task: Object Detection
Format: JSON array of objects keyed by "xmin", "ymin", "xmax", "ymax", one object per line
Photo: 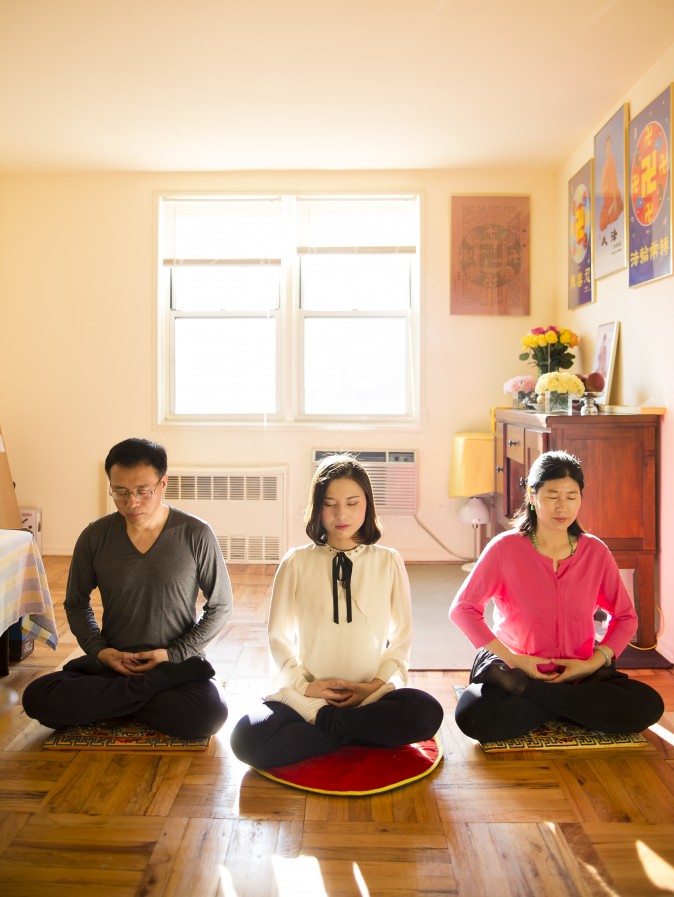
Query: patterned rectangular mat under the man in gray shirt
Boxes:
[{"xmin": 42, "ymin": 717, "xmax": 211, "ymax": 751}]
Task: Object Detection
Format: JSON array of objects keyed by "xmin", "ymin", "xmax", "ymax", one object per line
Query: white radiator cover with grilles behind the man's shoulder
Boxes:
[{"xmin": 109, "ymin": 467, "xmax": 287, "ymax": 564}]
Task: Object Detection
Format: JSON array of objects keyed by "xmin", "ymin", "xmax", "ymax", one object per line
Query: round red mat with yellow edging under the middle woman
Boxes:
[{"xmin": 257, "ymin": 735, "xmax": 442, "ymax": 797}]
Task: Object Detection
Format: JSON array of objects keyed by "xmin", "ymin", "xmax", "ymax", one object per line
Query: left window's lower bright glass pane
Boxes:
[{"xmin": 173, "ymin": 318, "xmax": 276, "ymax": 415}]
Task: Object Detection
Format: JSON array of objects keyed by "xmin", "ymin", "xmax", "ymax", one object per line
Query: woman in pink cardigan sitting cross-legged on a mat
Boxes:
[{"xmin": 449, "ymin": 452, "xmax": 664, "ymax": 742}]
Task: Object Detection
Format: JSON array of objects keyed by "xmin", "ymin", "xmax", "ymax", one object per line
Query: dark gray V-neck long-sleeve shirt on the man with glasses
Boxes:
[{"xmin": 65, "ymin": 508, "xmax": 232, "ymax": 661}]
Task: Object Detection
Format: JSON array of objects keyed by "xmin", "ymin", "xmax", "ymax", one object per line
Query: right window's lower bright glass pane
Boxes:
[{"xmin": 304, "ymin": 317, "xmax": 408, "ymax": 416}]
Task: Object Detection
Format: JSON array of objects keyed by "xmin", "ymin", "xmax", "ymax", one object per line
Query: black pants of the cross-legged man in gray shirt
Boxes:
[{"xmin": 23, "ymin": 657, "xmax": 227, "ymax": 738}]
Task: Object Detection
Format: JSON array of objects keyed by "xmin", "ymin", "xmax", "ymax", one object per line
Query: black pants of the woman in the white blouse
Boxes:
[{"xmin": 231, "ymin": 688, "xmax": 443, "ymax": 769}]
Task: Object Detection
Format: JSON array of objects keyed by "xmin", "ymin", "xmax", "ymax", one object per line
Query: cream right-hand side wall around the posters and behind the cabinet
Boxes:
[{"xmin": 556, "ymin": 46, "xmax": 674, "ymax": 661}]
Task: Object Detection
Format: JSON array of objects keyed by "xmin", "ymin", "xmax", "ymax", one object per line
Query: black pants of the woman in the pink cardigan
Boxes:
[{"xmin": 455, "ymin": 654, "xmax": 665, "ymax": 742}]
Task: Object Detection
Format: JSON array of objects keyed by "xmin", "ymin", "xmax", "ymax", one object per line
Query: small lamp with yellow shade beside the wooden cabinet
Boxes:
[{"xmin": 449, "ymin": 433, "xmax": 494, "ymax": 572}]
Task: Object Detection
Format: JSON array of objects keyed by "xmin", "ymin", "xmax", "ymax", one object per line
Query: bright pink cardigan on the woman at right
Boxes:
[{"xmin": 449, "ymin": 531, "xmax": 637, "ymax": 660}]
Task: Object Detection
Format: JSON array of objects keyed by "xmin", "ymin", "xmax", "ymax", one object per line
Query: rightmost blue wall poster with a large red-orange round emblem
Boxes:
[{"xmin": 628, "ymin": 84, "xmax": 672, "ymax": 287}]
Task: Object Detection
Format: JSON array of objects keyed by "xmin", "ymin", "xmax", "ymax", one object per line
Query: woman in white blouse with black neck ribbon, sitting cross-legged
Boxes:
[{"xmin": 231, "ymin": 454, "xmax": 443, "ymax": 768}]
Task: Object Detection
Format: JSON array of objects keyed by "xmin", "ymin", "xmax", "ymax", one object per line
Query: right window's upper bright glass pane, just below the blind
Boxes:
[{"xmin": 300, "ymin": 253, "xmax": 412, "ymax": 311}]
